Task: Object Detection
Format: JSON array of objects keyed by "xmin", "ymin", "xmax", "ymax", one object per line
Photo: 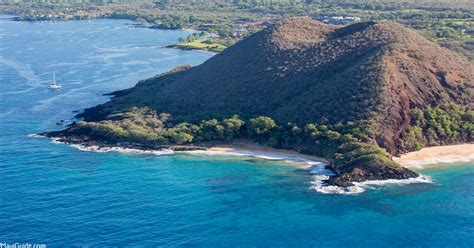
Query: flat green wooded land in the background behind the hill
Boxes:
[{"xmin": 0, "ymin": 0, "xmax": 474, "ymax": 60}]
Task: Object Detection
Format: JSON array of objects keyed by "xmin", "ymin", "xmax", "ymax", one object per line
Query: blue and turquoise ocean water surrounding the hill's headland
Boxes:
[{"xmin": 0, "ymin": 15, "xmax": 474, "ymax": 247}]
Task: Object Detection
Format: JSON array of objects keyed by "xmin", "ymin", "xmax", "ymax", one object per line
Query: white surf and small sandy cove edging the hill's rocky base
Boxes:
[{"xmin": 33, "ymin": 134, "xmax": 438, "ymax": 195}]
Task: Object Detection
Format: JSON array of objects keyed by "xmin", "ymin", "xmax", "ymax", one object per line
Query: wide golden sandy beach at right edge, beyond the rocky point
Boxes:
[{"xmin": 393, "ymin": 144, "xmax": 474, "ymax": 168}]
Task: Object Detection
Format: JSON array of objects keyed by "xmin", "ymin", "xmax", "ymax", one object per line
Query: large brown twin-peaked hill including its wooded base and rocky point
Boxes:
[{"xmin": 45, "ymin": 18, "xmax": 474, "ymax": 190}]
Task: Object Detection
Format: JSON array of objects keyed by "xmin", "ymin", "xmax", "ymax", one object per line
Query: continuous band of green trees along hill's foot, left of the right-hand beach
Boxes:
[{"xmin": 77, "ymin": 108, "xmax": 393, "ymax": 170}]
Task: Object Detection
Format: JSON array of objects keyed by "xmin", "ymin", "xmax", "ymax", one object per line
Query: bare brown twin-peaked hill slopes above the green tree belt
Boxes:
[{"xmin": 82, "ymin": 18, "xmax": 474, "ymax": 154}]
